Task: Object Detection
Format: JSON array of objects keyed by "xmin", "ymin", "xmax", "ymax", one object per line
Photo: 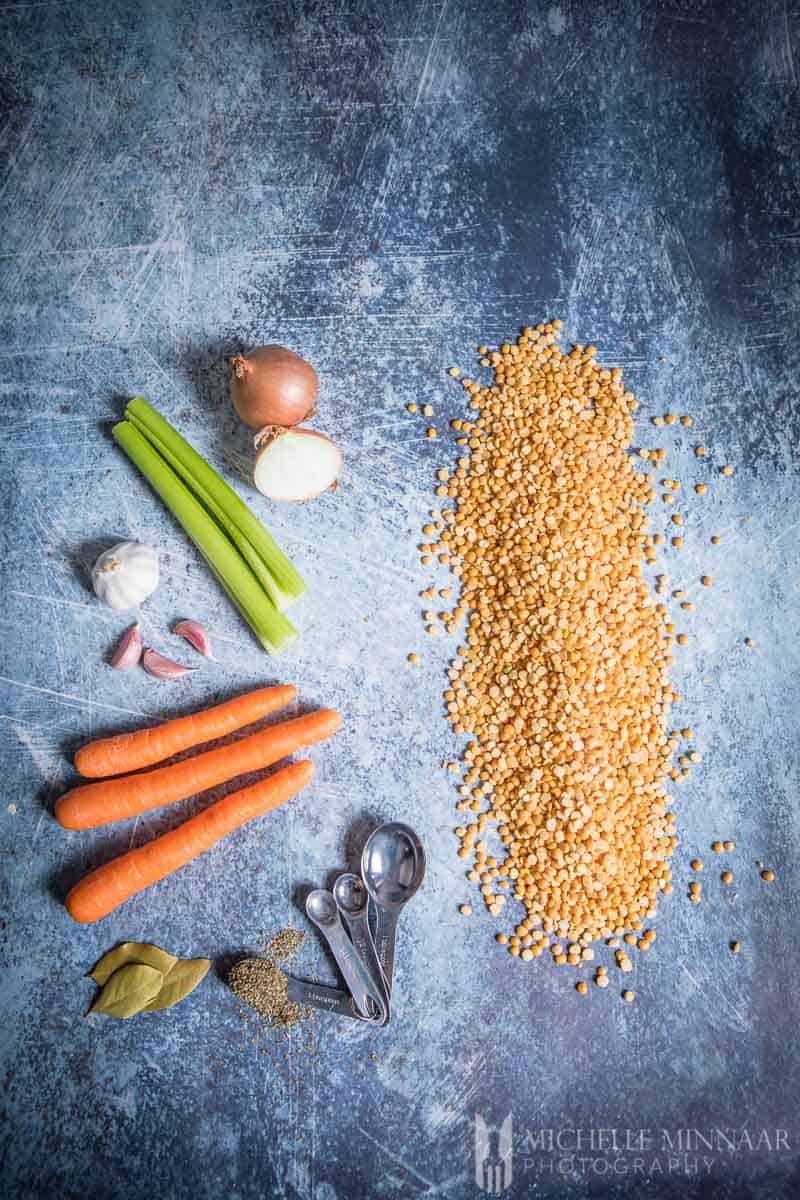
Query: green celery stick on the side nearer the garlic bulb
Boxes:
[{"xmin": 112, "ymin": 421, "xmax": 297, "ymax": 653}]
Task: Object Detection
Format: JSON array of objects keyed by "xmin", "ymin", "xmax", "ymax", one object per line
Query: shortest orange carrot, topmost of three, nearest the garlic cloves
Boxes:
[{"xmin": 76, "ymin": 684, "xmax": 297, "ymax": 779}]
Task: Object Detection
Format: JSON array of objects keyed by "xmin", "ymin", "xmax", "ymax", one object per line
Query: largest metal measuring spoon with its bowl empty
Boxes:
[{"xmin": 361, "ymin": 821, "xmax": 425, "ymax": 996}]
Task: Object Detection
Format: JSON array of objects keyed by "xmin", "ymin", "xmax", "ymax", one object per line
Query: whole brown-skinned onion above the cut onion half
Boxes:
[{"xmin": 229, "ymin": 346, "xmax": 319, "ymax": 430}]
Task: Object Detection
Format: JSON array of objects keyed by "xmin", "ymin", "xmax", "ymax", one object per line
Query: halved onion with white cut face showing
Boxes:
[{"xmin": 253, "ymin": 427, "xmax": 342, "ymax": 502}]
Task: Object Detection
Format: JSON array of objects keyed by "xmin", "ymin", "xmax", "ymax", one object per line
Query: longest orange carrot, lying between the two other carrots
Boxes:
[{"xmin": 55, "ymin": 708, "xmax": 342, "ymax": 829}]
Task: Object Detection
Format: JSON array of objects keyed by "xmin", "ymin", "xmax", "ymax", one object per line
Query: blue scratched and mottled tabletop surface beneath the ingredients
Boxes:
[{"xmin": 0, "ymin": 0, "xmax": 800, "ymax": 1200}]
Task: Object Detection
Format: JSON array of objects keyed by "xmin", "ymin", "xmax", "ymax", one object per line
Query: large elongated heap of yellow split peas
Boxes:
[{"xmin": 422, "ymin": 322, "xmax": 679, "ymax": 965}]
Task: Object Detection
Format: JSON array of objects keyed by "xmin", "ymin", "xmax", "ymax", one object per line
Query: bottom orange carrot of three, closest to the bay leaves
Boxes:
[{"xmin": 66, "ymin": 758, "xmax": 314, "ymax": 924}]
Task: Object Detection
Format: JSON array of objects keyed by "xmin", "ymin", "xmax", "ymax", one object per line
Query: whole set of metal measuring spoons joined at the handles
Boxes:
[{"xmin": 287, "ymin": 821, "xmax": 425, "ymax": 1025}]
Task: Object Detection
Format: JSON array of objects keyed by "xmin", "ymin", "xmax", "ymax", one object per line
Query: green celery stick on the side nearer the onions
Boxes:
[{"xmin": 125, "ymin": 396, "xmax": 306, "ymax": 612}]
